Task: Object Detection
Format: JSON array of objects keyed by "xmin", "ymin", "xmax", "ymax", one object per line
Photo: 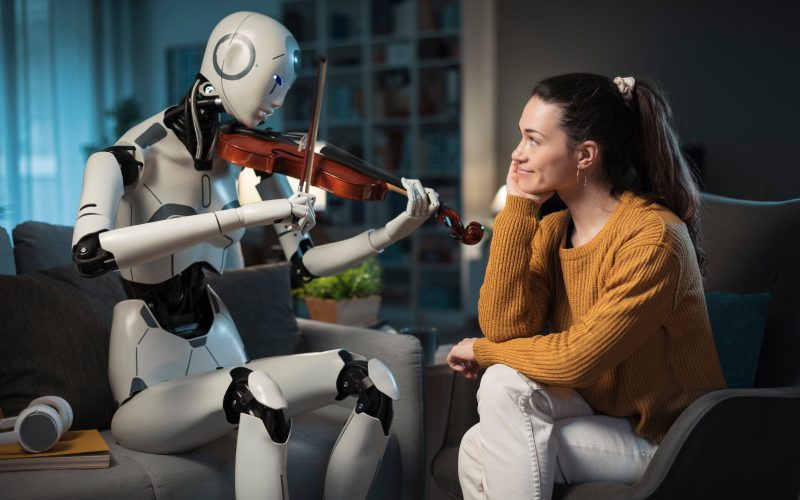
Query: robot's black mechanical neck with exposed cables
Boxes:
[{"xmin": 164, "ymin": 87, "xmax": 224, "ymax": 170}]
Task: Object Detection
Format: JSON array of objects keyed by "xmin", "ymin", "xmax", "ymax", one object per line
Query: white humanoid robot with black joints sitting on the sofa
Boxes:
[{"xmin": 73, "ymin": 12, "xmax": 439, "ymax": 499}]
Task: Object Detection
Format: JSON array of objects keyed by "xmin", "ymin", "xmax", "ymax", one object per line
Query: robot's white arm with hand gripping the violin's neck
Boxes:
[{"xmin": 275, "ymin": 179, "xmax": 439, "ymax": 276}]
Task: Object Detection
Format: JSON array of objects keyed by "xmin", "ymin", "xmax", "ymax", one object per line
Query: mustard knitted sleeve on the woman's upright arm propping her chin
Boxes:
[{"xmin": 478, "ymin": 195, "xmax": 550, "ymax": 342}]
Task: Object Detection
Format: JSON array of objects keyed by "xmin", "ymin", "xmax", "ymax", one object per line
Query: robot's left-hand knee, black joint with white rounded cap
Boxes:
[{"xmin": 222, "ymin": 367, "xmax": 292, "ymax": 443}]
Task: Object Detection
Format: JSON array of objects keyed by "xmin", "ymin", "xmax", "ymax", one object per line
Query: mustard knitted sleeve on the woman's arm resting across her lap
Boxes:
[{"xmin": 474, "ymin": 243, "xmax": 681, "ymax": 388}]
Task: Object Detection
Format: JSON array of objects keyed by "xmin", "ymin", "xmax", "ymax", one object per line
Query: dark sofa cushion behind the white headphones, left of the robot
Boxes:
[{"xmin": 0, "ymin": 268, "xmax": 123, "ymax": 429}]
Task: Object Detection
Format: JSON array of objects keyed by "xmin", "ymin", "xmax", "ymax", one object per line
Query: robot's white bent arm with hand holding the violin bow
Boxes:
[{"xmin": 72, "ymin": 152, "xmax": 314, "ymax": 277}]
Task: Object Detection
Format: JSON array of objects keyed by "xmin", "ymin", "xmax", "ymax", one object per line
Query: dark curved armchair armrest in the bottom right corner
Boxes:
[{"xmin": 555, "ymin": 386, "xmax": 800, "ymax": 500}]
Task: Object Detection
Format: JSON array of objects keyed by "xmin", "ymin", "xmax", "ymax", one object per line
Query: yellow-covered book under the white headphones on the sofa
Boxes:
[{"xmin": 0, "ymin": 429, "xmax": 111, "ymax": 472}]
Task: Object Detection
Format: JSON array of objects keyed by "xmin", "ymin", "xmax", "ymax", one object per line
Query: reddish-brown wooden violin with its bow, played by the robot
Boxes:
[{"xmin": 217, "ymin": 55, "xmax": 483, "ymax": 245}]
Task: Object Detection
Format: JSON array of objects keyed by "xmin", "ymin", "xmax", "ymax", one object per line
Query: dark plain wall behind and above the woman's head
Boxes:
[{"xmin": 496, "ymin": 0, "xmax": 800, "ymax": 200}]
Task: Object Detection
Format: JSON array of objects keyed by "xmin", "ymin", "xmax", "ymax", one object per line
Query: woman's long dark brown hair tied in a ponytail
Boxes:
[{"xmin": 533, "ymin": 73, "xmax": 706, "ymax": 271}]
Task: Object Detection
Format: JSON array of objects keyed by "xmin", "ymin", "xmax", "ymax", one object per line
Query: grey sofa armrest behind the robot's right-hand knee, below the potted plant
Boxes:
[{"xmin": 297, "ymin": 318, "xmax": 425, "ymax": 500}]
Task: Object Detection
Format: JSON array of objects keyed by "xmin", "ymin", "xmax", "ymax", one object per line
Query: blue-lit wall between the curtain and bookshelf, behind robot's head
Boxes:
[{"xmin": 132, "ymin": 0, "xmax": 277, "ymax": 116}]
